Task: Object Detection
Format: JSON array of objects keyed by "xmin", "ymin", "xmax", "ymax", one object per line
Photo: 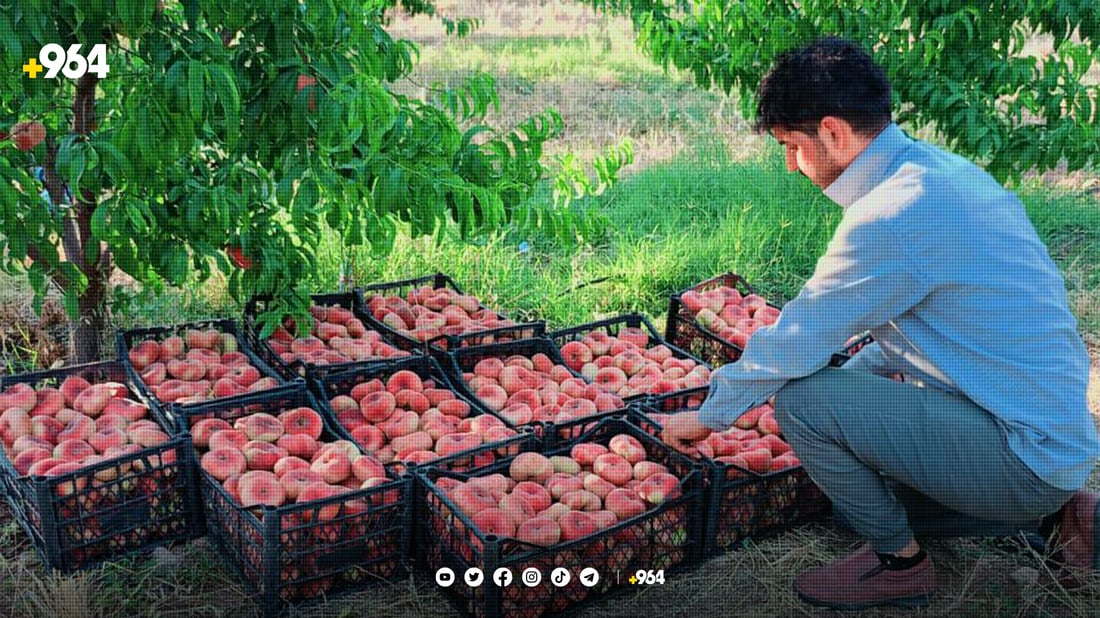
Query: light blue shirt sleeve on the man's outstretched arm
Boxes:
[{"xmin": 700, "ymin": 208, "xmax": 930, "ymax": 430}]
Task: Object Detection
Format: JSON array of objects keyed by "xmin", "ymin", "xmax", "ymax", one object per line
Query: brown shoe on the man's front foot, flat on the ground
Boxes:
[{"xmin": 794, "ymin": 544, "xmax": 936, "ymax": 609}]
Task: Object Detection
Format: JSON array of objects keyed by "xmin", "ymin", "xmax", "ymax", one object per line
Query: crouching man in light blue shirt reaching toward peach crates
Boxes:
[{"xmin": 664, "ymin": 38, "xmax": 1100, "ymax": 609}]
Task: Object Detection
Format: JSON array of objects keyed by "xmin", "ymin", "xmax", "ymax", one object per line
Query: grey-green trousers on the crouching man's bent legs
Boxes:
[{"xmin": 776, "ymin": 367, "xmax": 1074, "ymax": 553}]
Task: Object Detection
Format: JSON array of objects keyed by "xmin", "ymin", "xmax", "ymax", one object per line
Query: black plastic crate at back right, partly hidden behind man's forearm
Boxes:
[{"xmin": 664, "ymin": 273, "xmax": 872, "ymax": 367}]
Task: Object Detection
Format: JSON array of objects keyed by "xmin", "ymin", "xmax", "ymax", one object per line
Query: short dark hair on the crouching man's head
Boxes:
[{"xmin": 756, "ymin": 36, "xmax": 890, "ymax": 135}]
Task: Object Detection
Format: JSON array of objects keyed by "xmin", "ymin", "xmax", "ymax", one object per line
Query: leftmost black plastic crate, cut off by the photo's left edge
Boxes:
[{"xmin": 0, "ymin": 361, "xmax": 204, "ymax": 573}]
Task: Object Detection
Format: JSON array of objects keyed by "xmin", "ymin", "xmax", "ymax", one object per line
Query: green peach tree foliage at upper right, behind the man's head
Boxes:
[{"xmin": 581, "ymin": 0, "xmax": 1100, "ymax": 179}]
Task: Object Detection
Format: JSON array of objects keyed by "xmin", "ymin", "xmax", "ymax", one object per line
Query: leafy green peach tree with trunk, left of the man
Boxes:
[{"xmin": 0, "ymin": 0, "xmax": 630, "ymax": 362}]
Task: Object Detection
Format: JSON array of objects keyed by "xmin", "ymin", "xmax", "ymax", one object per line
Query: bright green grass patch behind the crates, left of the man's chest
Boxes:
[{"xmin": 319, "ymin": 142, "xmax": 839, "ymax": 325}]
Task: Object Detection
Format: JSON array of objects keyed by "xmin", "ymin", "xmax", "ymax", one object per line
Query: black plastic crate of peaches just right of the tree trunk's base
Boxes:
[{"xmin": 117, "ymin": 319, "xmax": 286, "ymax": 422}]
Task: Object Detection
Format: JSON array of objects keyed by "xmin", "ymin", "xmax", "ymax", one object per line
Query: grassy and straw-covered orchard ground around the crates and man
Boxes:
[{"xmin": 0, "ymin": 0, "xmax": 1100, "ymax": 616}]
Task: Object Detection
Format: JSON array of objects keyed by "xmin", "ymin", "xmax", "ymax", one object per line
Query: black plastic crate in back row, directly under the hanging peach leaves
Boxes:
[{"xmin": 244, "ymin": 291, "xmax": 424, "ymax": 379}]
